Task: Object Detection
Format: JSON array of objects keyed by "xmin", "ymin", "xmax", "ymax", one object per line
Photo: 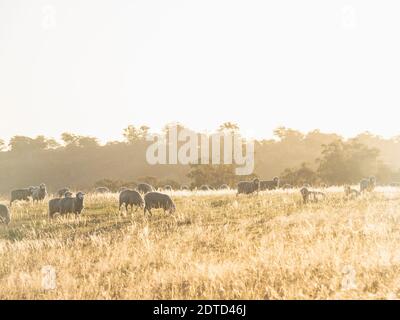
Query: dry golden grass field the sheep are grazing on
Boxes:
[{"xmin": 0, "ymin": 188, "xmax": 400, "ymax": 299}]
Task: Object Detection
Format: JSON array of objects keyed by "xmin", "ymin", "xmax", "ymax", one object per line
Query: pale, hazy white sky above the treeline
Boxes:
[{"xmin": 0, "ymin": 0, "xmax": 400, "ymax": 141}]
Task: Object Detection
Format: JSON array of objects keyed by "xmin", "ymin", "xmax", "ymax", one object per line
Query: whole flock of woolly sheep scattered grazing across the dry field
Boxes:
[{"xmin": 0, "ymin": 177, "xmax": 392, "ymax": 224}]
